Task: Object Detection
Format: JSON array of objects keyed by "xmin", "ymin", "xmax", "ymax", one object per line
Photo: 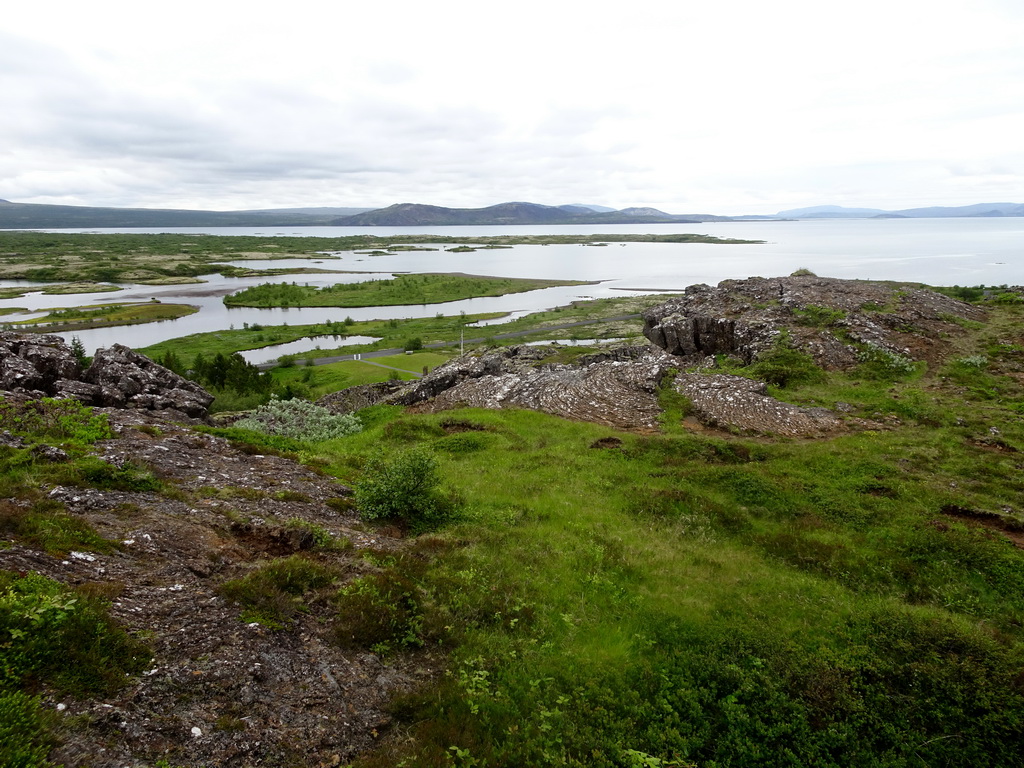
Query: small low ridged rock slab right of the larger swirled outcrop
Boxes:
[{"xmin": 675, "ymin": 374, "xmax": 845, "ymax": 437}]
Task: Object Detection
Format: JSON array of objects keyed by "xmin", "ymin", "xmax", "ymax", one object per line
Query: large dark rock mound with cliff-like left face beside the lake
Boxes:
[{"xmin": 644, "ymin": 275, "xmax": 985, "ymax": 370}]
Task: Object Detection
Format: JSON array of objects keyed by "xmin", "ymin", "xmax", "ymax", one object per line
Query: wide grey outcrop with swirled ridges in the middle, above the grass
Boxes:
[{"xmin": 388, "ymin": 346, "xmax": 677, "ymax": 429}]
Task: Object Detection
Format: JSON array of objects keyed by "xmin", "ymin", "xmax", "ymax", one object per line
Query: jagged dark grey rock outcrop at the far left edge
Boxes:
[{"xmin": 0, "ymin": 333, "xmax": 213, "ymax": 419}]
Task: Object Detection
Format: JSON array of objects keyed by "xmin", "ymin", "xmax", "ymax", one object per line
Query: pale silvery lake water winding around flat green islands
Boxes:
[{"xmin": 0, "ymin": 218, "xmax": 1024, "ymax": 350}]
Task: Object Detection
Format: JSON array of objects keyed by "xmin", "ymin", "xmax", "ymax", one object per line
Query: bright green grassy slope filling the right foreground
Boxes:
[{"xmin": 299, "ymin": 308, "xmax": 1024, "ymax": 768}]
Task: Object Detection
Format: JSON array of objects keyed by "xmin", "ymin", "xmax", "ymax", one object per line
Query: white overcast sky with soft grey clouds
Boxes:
[{"xmin": 0, "ymin": 0, "xmax": 1024, "ymax": 214}]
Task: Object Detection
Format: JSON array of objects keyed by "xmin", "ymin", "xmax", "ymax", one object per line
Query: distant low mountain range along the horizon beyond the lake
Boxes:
[{"xmin": 0, "ymin": 200, "xmax": 1024, "ymax": 229}]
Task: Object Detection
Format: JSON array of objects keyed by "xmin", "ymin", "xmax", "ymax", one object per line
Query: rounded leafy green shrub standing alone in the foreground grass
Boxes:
[{"xmin": 355, "ymin": 449, "xmax": 454, "ymax": 530}]
